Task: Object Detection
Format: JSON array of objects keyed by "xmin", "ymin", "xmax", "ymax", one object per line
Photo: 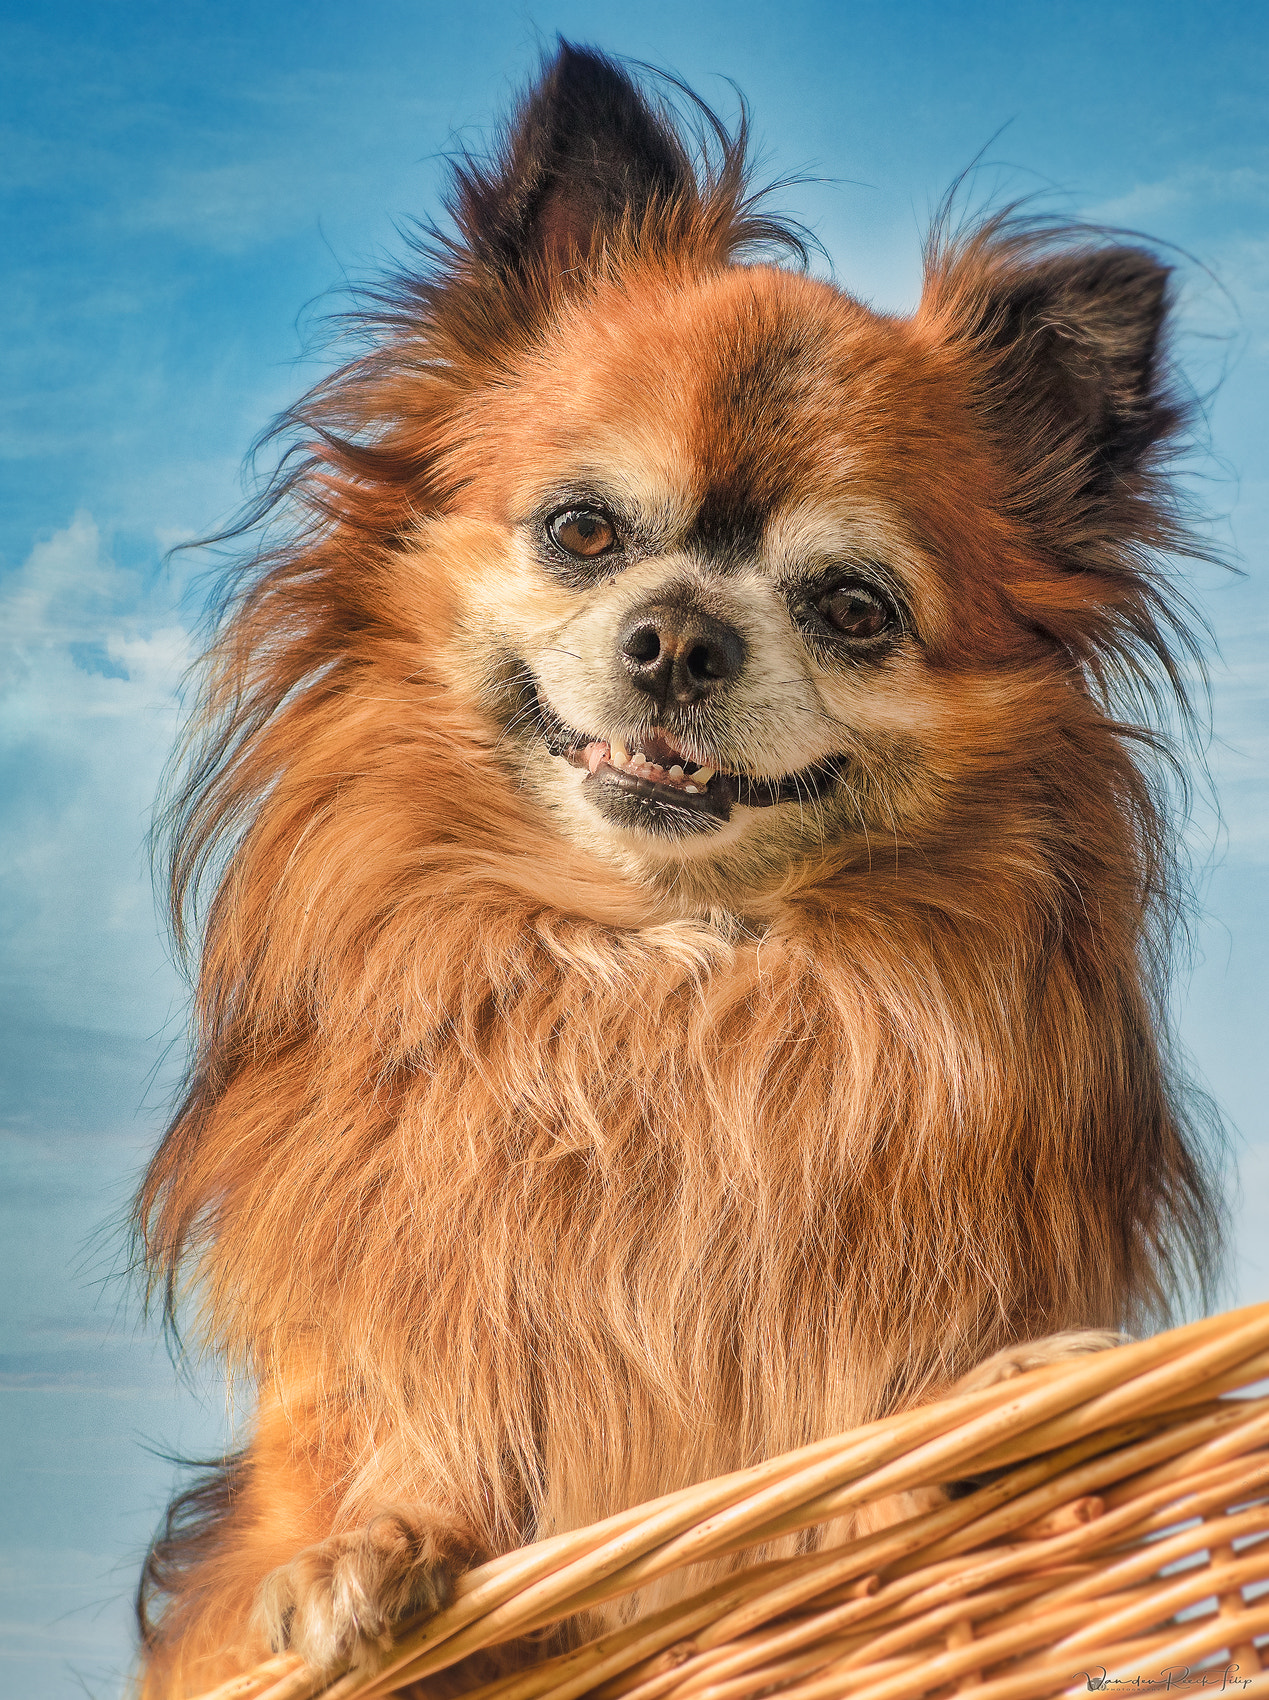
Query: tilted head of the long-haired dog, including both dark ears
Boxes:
[{"xmin": 195, "ymin": 48, "xmax": 1197, "ymax": 908}]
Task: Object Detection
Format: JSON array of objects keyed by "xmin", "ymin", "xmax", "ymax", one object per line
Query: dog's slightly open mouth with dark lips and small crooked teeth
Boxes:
[{"xmin": 538, "ymin": 683, "xmax": 840, "ymax": 833}]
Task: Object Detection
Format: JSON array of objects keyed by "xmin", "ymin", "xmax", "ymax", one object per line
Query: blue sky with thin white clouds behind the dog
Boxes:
[{"xmin": 0, "ymin": 0, "xmax": 1269, "ymax": 1700}]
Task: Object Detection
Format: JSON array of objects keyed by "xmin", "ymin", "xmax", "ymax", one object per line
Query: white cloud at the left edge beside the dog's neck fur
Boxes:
[{"xmin": 0, "ymin": 513, "xmax": 191, "ymax": 1032}]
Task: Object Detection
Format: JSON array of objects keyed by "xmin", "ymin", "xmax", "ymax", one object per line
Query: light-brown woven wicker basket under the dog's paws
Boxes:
[{"xmin": 190, "ymin": 1304, "xmax": 1269, "ymax": 1700}]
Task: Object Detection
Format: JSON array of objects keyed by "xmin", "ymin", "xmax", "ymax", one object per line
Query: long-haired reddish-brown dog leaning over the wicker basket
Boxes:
[{"xmin": 136, "ymin": 44, "xmax": 1218, "ymax": 1697}]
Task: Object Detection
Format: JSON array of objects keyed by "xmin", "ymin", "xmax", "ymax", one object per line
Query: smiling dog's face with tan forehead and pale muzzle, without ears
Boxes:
[{"xmin": 432, "ymin": 267, "xmax": 1053, "ymax": 901}]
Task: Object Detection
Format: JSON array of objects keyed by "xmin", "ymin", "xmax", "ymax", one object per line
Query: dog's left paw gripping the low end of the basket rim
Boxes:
[{"xmin": 257, "ymin": 1510, "xmax": 451, "ymax": 1669}]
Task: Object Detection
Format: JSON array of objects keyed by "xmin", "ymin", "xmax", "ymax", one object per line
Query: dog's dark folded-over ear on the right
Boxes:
[{"xmin": 934, "ymin": 228, "xmax": 1184, "ymax": 566}]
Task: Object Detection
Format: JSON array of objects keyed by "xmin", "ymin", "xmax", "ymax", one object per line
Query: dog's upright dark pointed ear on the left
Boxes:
[{"xmin": 454, "ymin": 43, "xmax": 696, "ymax": 281}]
